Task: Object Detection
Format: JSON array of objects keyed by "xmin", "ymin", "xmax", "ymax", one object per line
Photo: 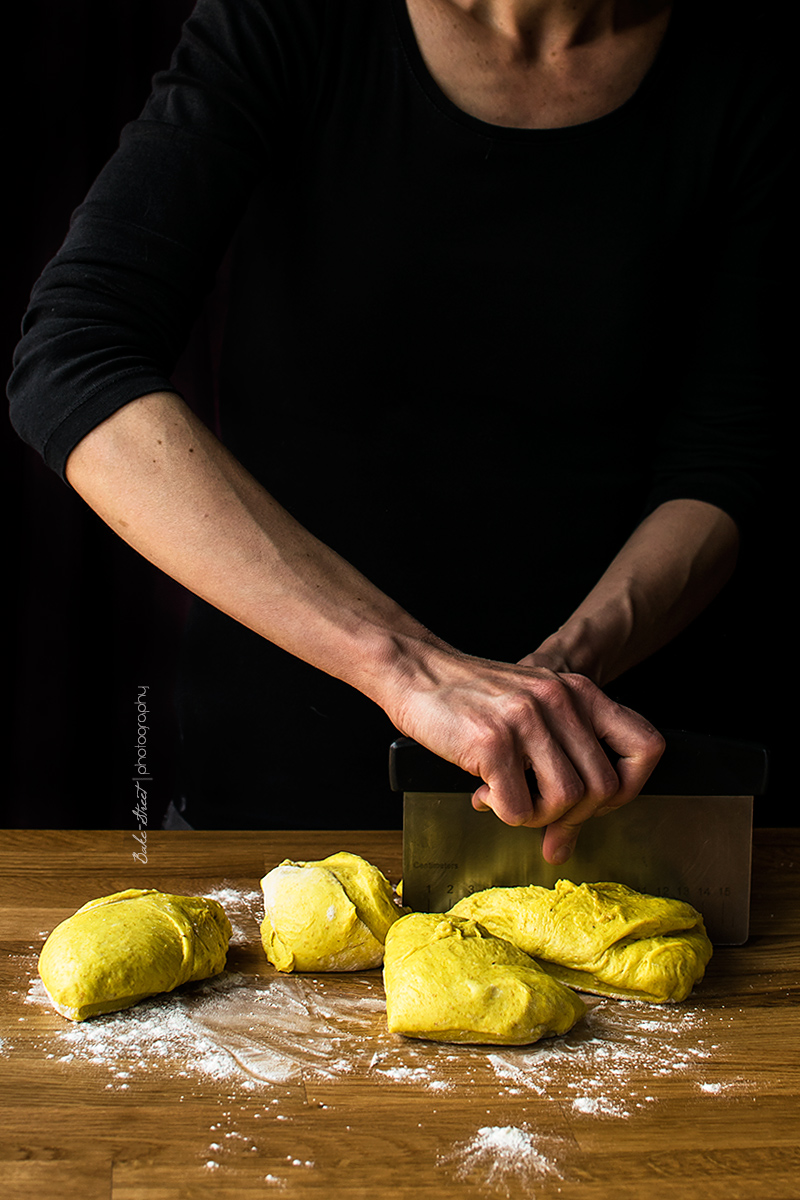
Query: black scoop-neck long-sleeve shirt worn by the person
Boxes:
[{"xmin": 10, "ymin": 0, "xmax": 790, "ymax": 824}]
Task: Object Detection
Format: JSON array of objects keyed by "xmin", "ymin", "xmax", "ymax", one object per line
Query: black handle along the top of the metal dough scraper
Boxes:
[{"xmin": 389, "ymin": 730, "xmax": 768, "ymax": 796}]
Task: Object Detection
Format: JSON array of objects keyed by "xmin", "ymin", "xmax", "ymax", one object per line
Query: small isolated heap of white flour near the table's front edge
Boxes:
[{"xmin": 439, "ymin": 1126, "xmax": 563, "ymax": 1193}]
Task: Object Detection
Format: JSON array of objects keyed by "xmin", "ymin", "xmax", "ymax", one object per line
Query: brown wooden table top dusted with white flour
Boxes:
[{"xmin": 0, "ymin": 829, "xmax": 800, "ymax": 1200}]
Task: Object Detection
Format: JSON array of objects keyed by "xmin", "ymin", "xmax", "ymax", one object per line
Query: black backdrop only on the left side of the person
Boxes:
[{"xmin": 2, "ymin": 0, "xmax": 201, "ymax": 828}]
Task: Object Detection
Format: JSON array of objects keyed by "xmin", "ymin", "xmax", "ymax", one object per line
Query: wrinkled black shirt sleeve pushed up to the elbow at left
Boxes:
[{"xmin": 8, "ymin": 0, "xmax": 320, "ymax": 478}]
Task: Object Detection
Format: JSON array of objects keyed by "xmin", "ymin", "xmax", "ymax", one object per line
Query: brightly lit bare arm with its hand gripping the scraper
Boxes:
[{"xmin": 67, "ymin": 394, "xmax": 663, "ymax": 862}]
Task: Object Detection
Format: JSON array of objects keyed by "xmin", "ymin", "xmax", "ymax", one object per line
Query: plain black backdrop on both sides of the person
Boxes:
[{"xmin": 6, "ymin": 0, "xmax": 798, "ymax": 828}]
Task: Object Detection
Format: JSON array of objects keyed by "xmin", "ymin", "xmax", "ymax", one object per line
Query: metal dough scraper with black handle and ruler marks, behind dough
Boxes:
[{"xmin": 390, "ymin": 731, "xmax": 766, "ymax": 946}]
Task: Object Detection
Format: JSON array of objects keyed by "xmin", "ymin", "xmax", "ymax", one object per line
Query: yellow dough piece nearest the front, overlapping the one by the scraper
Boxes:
[{"xmin": 384, "ymin": 912, "xmax": 585, "ymax": 1045}]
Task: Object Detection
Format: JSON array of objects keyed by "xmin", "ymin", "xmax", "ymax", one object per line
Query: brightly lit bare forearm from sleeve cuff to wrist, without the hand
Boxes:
[{"xmin": 67, "ymin": 394, "xmax": 443, "ymax": 703}]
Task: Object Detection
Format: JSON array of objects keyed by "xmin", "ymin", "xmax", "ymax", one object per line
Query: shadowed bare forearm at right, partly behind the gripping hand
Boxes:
[{"xmin": 522, "ymin": 499, "xmax": 739, "ymax": 686}]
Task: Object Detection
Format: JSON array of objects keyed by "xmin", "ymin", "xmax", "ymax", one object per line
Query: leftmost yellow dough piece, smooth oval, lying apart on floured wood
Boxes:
[{"xmin": 38, "ymin": 888, "xmax": 231, "ymax": 1021}]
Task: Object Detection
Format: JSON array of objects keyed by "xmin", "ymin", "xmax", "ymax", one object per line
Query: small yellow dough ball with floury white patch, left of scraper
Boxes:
[{"xmin": 261, "ymin": 851, "xmax": 402, "ymax": 971}]
